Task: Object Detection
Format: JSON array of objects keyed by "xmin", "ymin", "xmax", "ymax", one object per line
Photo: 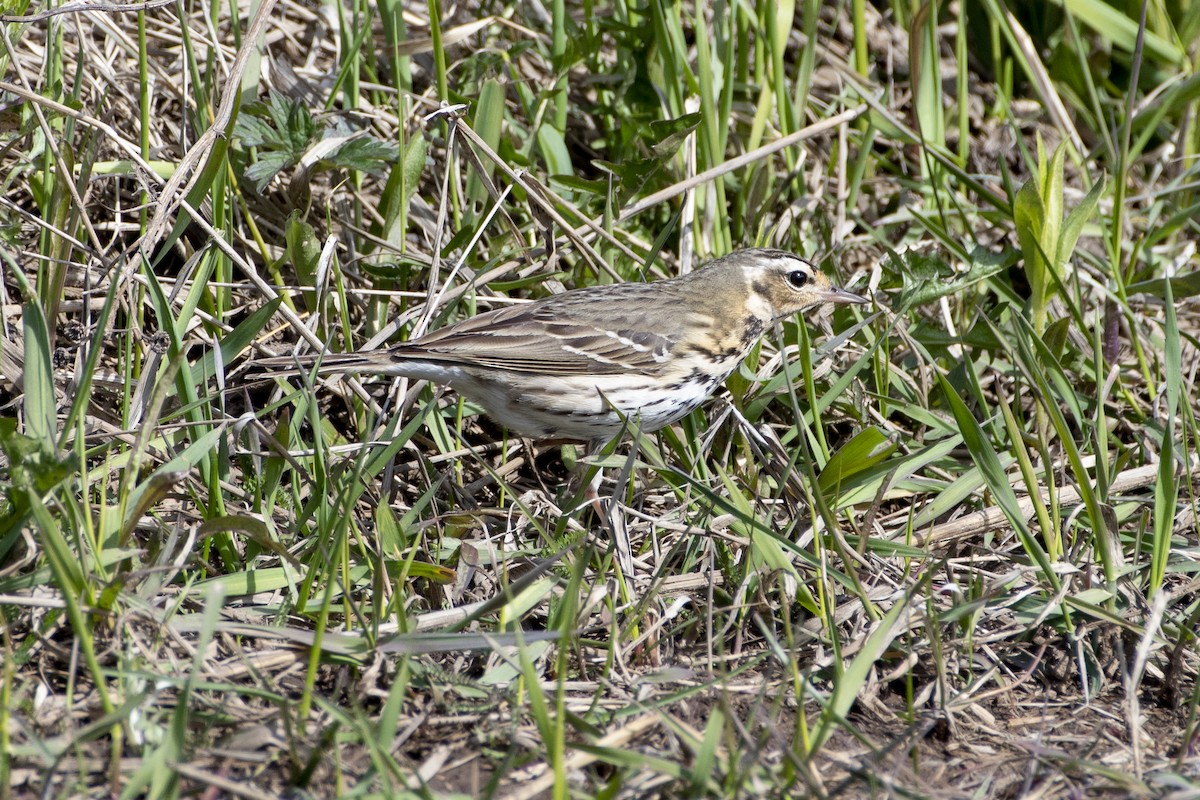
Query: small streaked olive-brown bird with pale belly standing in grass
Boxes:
[{"xmin": 256, "ymin": 248, "xmax": 870, "ymax": 445}]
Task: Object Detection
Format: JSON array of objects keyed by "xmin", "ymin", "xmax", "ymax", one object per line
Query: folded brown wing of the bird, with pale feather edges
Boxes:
[{"xmin": 389, "ymin": 284, "xmax": 683, "ymax": 375}]
